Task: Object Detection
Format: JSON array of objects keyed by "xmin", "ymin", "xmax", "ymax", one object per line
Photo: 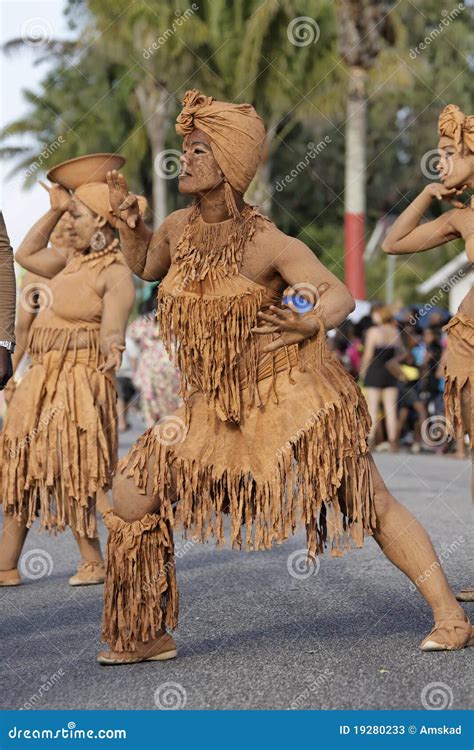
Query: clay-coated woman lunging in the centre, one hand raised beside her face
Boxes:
[{"xmin": 98, "ymin": 90, "xmax": 472, "ymax": 665}]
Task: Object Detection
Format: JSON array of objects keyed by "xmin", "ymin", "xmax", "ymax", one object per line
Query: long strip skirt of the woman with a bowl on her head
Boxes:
[{"xmin": 1, "ymin": 349, "xmax": 117, "ymax": 538}]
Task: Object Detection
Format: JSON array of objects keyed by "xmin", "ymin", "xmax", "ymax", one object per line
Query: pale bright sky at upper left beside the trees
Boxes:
[{"xmin": 0, "ymin": 0, "xmax": 68, "ymax": 250}]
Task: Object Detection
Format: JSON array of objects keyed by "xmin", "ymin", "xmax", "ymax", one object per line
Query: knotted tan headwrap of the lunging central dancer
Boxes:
[{"xmin": 176, "ymin": 89, "xmax": 265, "ymax": 218}]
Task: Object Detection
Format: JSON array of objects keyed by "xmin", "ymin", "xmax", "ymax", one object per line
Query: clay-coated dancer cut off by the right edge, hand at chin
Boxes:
[{"xmin": 383, "ymin": 104, "xmax": 474, "ymax": 602}]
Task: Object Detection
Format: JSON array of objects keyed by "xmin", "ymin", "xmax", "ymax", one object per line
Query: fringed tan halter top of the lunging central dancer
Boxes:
[{"xmin": 157, "ymin": 206, "xmax": 320, "ymax": 423}]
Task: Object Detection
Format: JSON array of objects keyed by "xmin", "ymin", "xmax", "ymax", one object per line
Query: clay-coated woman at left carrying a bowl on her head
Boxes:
[{"xmin": 0, "ymin": 155, "xmax": 134, "ymax": 586}]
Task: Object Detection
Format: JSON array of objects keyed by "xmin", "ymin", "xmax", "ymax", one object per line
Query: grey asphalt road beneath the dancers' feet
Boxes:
[{"xmin": 0, "ymin": 420, "xmax": 474, "ymax": 709}]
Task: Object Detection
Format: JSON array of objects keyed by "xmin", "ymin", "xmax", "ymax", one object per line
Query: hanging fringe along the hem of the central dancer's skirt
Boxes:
[{"xmin": 120, "ymin": 397, "xmax": 376, "ymax": 556}]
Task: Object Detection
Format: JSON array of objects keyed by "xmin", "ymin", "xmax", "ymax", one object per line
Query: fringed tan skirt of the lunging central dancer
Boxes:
[{"xmin": 118, "ymin": 334, "xmax": 376, "ymax": 556}]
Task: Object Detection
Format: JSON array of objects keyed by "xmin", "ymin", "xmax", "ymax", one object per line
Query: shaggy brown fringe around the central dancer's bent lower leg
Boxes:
[{"xmin": 102, "ymin": 510, "xmax": 179, "ymax": 652}]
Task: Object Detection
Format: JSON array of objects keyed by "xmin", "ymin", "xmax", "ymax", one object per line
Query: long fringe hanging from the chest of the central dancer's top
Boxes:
[{"xmin": 157, "ymin": 289, "xmax": 263, "ymax": 422}]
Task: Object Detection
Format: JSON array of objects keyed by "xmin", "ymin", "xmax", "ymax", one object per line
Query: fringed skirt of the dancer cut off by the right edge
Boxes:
[{"xmin": 443, "ymin": 313, "xmax": 474, "ymax": 443}]
